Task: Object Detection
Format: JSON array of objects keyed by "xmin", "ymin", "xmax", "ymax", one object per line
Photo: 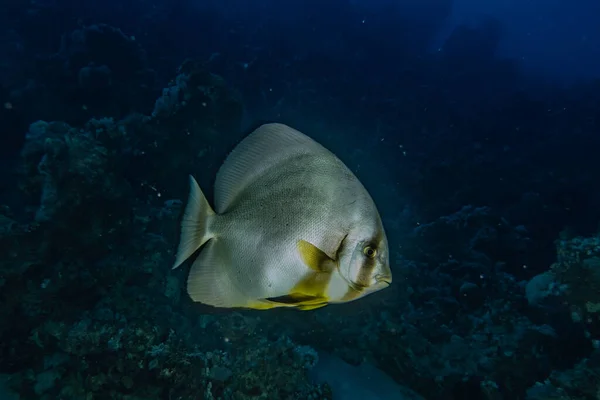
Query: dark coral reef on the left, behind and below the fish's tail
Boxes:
[{"xmin": 0, "ymin": 62, "xmax": 326, "ymax": 400}]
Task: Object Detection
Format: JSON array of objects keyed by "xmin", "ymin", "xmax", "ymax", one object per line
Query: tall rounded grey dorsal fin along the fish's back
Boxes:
[{"xmin": 215, "ymin": 123, "xmax": 329, "ymax": 214}]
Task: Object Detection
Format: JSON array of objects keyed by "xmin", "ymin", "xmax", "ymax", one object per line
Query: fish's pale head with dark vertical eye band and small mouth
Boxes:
[{"xmin": 338, "ymin": 221, "xmax": 392, "ymax": 296}]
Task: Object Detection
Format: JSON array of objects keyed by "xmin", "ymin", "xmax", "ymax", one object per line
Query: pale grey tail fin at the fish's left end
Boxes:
[{"xmin": 173, "ymin": 175, "xmax": 216, "ymax": 269}]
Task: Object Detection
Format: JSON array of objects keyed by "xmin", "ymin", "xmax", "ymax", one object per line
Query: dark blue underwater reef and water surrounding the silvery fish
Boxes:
[{"xmin": 0, "ymin": 0, "xmax": 600, "ymax": 400}]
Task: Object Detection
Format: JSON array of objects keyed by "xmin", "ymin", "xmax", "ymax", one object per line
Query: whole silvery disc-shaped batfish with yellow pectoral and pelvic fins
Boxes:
[{"xmin": 173, "ymin": 123, "xmax": 392, "ymax": 310}]
